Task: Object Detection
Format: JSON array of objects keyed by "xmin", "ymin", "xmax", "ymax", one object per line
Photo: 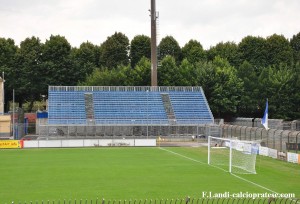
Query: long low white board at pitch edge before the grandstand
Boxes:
[{"xmin": 24, "ymin": 139, "xmax": 156, "ymax": 148}]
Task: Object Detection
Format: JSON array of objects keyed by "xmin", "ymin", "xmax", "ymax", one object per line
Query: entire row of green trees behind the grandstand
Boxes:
[{"xmin": 0, "ymin": 32, "xmax": 300, "ymax": 120}]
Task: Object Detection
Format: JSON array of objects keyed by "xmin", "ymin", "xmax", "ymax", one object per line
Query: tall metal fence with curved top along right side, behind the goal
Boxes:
[{"xmin": 220, "ymin": 124, "xmax": 300, "ymax": 153}]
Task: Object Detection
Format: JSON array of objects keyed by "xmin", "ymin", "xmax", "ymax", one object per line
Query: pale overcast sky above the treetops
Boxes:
[{"xmin": 0, "ymin": 0, "xmax": 300, "ymax": 49}]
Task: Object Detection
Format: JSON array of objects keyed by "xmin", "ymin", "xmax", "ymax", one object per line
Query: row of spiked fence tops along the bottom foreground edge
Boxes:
[{"xmin": 8, "ymin": 198, "xmax": 300, "ymax": 204}]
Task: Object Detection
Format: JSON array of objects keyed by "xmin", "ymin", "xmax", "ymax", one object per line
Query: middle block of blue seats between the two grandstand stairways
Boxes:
[{"xmin": 93, "ymin": 91, "xmax": 168, "ymax": 124}]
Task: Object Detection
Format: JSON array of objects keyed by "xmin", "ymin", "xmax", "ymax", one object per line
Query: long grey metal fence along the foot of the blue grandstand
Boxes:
[{"xmin": 36, "ymin": 124, "xmax": 220, "ymax": 139}]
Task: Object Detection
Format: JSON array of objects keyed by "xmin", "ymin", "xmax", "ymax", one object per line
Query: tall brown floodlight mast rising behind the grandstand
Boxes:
[{"xmin": 150, "ymin": 0, "xmax": 157, "ymax": 86}]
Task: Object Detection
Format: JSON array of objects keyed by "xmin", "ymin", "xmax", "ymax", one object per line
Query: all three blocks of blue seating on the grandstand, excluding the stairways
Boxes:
[{"xmin": 48, "ymin": 87, "xmax": 214, "ymax": 125}]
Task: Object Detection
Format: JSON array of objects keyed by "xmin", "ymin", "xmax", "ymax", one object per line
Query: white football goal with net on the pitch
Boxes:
[{"xmin": 208, "ymin": 136, "xmax": 260, "ymax": 174}]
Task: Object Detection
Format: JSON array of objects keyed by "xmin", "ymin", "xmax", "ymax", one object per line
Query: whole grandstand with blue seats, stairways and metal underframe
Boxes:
[{"xmin": 40, "ymin": 86, "xmax": 214, "ymax": 136}]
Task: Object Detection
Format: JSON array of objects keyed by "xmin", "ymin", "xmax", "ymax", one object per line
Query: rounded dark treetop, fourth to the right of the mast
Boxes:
[{"xmin": 238, "ymin": 36, "xmax": 268, "ymax": 69}]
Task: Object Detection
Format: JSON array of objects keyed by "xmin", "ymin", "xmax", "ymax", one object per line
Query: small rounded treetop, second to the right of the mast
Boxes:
[{"xmin": 182, "ymin": 40, "xmax": 206, "ymax": 64}]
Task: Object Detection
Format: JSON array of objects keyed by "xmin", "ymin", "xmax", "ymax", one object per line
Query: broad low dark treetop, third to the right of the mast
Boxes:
[{"xmin": 207, "ymin": 42, "xmax": 239, "ymax": 67}]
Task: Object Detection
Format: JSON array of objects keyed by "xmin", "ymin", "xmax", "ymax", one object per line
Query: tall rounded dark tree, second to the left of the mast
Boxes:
[{"xmin": 100, "ymin": 32, "xmax": 129, "ymax": 69}]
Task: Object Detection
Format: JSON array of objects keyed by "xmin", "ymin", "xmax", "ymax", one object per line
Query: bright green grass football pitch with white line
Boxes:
[{"xmin": 0, "ymin": 147, "xmax": 300, "ymax": 203}]
